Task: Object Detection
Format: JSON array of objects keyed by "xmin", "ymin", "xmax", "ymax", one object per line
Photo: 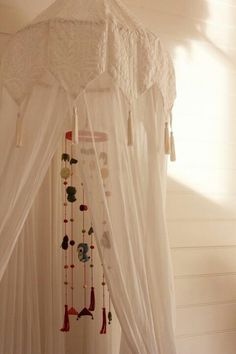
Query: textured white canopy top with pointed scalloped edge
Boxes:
[{"xmin": 1, "ymin": 0, "xmax": 175, "ymax": 112}]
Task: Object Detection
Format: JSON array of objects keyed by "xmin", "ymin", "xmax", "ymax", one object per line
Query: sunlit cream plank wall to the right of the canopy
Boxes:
[{"xmin": 0, "ymin": 0, "xmax": 236, "ymax": 354}]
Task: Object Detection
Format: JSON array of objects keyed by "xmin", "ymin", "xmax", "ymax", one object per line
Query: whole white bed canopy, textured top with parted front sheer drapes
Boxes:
[{"xmin": 0, "ymin": 0, "xmax": 175, "ymax": 354}]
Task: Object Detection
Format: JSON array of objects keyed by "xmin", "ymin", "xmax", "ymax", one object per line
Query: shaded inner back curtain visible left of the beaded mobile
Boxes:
[{"xmin": 0, "ymin": 149, "xmax": 65, "ymax": 354}]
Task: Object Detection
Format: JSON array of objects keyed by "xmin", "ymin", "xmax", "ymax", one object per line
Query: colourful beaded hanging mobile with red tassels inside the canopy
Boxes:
[{"xmin": 60, "ymin": 131, "xmax": 112, "ymax": 334}]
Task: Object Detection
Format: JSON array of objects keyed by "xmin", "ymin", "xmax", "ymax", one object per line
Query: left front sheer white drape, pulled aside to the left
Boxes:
[{"xmin": 0, "ymin": 84, "xmax": 68, "ymax": 279}]
